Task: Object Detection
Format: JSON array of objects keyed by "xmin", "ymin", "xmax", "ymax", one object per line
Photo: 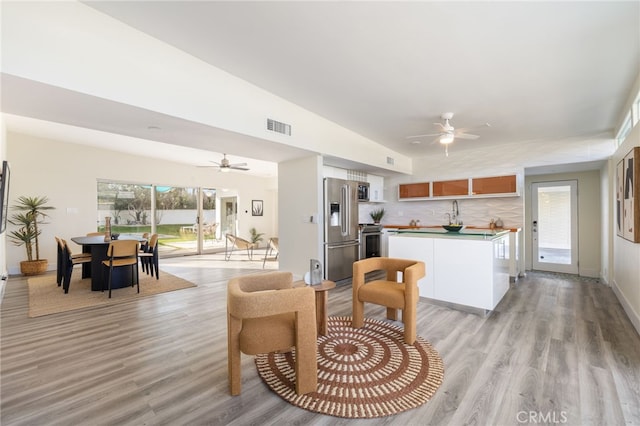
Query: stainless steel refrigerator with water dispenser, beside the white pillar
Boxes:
[{"xmin": 324, "ymin": 178, "xmax": 360, "ymax": 281}]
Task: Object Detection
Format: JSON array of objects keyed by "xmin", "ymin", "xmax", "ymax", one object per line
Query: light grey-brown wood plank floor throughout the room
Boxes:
[{"xmin": 0, "ymin": 256, "xmax": 640, "ymax": 426}]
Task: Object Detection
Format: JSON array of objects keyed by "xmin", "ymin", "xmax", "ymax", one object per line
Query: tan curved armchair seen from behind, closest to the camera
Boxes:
[{"xmin": 227, "ymin": 271, "xmax": 318, "ymax": 395}]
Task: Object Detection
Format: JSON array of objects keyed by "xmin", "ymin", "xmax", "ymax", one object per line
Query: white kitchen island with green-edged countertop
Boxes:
[{"xmin": 389, "ymin": 229, "xmax": 509, "ymax": 313}]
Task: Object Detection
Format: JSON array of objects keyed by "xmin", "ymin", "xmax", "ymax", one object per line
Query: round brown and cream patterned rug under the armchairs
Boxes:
[{"xmin": 255, "ymin": 317, "xmax": 444, "ymax": 419}]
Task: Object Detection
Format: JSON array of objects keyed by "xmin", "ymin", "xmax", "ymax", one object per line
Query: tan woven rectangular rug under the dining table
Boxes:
[{"xmin": 27, "ymin": 270, "xmax": 196, "ymax": 318}]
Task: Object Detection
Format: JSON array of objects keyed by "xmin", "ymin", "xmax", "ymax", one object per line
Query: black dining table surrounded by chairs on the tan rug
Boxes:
[{"xmin": 71, "ymin": 234, "xmax": 146, "ymax": 291}]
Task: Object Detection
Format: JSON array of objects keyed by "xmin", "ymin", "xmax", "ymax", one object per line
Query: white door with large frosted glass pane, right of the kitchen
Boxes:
[{"xmin": 531, "ymin": 180, "xmax": 578, "ymax": 274}]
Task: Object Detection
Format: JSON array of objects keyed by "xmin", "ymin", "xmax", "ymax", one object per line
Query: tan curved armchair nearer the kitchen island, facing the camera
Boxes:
[{"xmin": 352, "ymin": 257, "xmax": 425, "ymax": 345}]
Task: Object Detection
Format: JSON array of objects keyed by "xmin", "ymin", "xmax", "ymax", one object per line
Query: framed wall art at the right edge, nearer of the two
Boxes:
[{"xmin": 622, "ymin": 147, "xmax": 640, "ymax": 243}]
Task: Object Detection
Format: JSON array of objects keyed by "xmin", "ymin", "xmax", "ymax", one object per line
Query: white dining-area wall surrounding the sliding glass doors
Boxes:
[{"xmin": 2, "ymin": 132, "xmax": 277, "ymax": 274}]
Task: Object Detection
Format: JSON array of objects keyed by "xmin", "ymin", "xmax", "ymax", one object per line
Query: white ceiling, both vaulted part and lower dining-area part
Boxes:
[{"xmin": 2, "ymin": 1, "xmax": 640, "ymax": 175}]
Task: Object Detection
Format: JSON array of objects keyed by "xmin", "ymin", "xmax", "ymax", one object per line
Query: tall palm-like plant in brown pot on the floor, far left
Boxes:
[{"xmin": 9, "ymin": 196, "xmax": 55, "ymax": 275}]
